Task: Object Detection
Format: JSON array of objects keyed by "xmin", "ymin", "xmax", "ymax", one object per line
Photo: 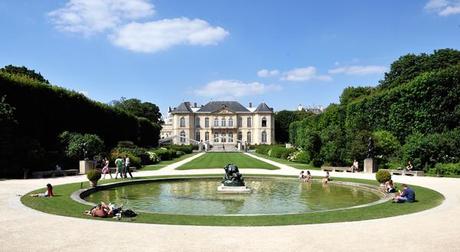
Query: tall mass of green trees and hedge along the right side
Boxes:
[{"xmin": 289, "ymin": 49, "xmax": 460, "ymax": 169}]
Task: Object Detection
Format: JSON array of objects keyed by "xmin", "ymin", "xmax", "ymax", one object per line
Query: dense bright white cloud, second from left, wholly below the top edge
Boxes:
[{"xmin": 110, "ymin": 18, "xmax": 229, "ymax": 53}]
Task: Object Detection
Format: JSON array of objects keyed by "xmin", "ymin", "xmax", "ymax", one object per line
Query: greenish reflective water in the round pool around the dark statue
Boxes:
[{"xmin": 85, "ymin": 178, "xmax": 381, "ymax": 215}]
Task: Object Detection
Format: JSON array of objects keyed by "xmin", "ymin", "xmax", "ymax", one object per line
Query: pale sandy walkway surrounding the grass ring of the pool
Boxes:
[{"xmin": 0, "ymin": 155, "xmax": 460, "ymax": 252}]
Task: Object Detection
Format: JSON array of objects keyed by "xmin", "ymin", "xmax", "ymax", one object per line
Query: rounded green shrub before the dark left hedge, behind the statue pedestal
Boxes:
[{"xmin": 59, "ymin": 131, "xmax": 104, "ymax": 159}]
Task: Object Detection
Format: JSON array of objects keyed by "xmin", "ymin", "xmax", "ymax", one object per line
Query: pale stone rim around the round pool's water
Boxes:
[{"xmin": 70, "ymin": 174, "xmax": 393, "ymax": 217}]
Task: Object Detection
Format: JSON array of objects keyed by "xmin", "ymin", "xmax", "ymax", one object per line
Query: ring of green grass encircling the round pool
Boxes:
[{"xmin": 21, "ymin": 174, "xmax": 444, "ymax": 226}]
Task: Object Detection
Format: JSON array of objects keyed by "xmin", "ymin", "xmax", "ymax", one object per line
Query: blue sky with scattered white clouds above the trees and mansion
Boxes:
[{"xmin": 0, "ymin": 0, "xmax": 460, "ymax": 113}]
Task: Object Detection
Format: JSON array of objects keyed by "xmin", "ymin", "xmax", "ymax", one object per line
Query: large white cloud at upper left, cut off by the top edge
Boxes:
[{"xmin": 48, "ymin": 0, "xmax": 155, "ymax": 36}]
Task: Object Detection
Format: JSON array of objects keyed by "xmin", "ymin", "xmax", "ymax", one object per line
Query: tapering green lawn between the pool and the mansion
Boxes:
[{"xmin": 177, "ymin": 152, "xmax": 279, "ymax": 170}]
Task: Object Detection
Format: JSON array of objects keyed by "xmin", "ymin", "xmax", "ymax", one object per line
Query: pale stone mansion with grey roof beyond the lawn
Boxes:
[{"xmin": 160, "ymin": 101, "xmax": 275, "ymax": 146}]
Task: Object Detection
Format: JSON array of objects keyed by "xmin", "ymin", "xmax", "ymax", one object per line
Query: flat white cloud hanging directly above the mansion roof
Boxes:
[{"xmin": 195, "ymin": 80, "xmax": 281, "ymax": 99}]
